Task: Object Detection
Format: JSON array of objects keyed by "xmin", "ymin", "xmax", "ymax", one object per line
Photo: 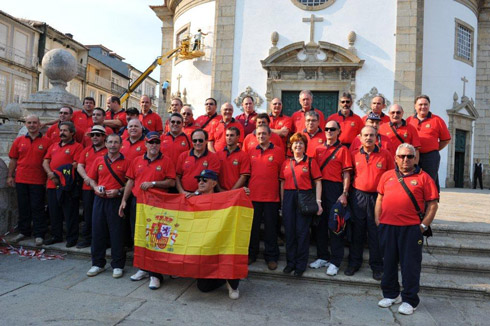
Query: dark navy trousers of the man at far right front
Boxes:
[{"xmin": 379, "ymin": 224, "xmax": 424, "ymax": 307}]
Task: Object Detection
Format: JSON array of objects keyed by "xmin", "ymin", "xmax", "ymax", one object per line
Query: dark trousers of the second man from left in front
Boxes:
[{"xmin": 48, "ymin": 189, "xmax": 79, "ymax": 242}]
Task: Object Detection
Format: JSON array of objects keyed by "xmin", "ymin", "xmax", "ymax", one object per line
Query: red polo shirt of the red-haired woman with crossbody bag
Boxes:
[{"xmin": 279, "ymin": 155, "xmax": 322, "ymax": 190}]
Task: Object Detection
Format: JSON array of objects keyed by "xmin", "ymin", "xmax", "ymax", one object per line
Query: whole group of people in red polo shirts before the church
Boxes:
[{"xmin": 7, "ymin": 90, "xmax": 451, "ymax": 314}]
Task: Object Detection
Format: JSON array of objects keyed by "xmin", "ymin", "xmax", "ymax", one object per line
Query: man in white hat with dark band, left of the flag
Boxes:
[{"xmin": 77, "ymin": 125, "xmax": 107, "ymax": 249}]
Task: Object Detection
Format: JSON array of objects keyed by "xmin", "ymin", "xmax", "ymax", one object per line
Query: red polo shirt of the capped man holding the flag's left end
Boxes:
[{"xmin": 126, "ymin": 153, "xmax": 175, "ymax": 198}]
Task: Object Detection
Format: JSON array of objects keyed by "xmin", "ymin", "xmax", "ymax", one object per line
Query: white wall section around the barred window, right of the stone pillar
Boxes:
[{"xmin": 422, "ymin": 0, "xmax": 478, "ymax": 186}]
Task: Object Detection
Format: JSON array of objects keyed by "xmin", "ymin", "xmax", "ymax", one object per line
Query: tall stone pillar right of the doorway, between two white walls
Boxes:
[{"xmin": 393, "ymin": 0, "xmax": 424, "ymax": 115}]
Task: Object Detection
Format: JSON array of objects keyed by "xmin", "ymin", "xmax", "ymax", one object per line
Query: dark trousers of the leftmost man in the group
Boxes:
[{"xmin": 15, "ymin": 183, "xmax": 47, "ymax": 238}]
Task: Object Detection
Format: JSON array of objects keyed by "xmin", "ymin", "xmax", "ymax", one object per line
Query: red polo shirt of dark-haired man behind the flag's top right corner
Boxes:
[{"xmin": 218, "ymin": 147, "xmax": 250, "ymax": 190}]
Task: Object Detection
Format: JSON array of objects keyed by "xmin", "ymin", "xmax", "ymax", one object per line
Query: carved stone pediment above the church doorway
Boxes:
[{"xmin": 261, "ymin": 41, "xmax": 364, "ymax": 108}]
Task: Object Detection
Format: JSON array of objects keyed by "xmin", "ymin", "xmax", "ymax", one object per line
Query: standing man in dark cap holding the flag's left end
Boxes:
[{"xmin": 119, "ymin": 131, "xmax": 178, "ymax": 290}]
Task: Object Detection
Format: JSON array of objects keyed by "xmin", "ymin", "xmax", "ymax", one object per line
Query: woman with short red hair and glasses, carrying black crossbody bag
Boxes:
[{"xmin": 279, "ymin": 133, "xmax": 323, "ymax": 277}]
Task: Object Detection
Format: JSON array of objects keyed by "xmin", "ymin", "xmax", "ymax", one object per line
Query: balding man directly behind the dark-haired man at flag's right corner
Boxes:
[{"xmin": 208, "ymin": 102, "xmax": 244, "ymax": 153}]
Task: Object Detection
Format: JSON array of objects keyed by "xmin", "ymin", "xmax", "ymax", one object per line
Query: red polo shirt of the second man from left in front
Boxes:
[{"xmin": 44, "ymin": 140, "xmax": 83, "ymax": 189}]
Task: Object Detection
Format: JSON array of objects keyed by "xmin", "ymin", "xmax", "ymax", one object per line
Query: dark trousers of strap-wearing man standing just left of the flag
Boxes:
[{"xmin": 91, "ymin": 196, "xmax": 126, "ymax": 268}]
